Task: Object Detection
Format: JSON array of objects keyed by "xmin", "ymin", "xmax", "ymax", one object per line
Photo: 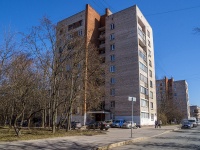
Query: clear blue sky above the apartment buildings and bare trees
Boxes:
[{"xmin": 0, "ymin": 0, "xmax": 200, "ymax": 106}]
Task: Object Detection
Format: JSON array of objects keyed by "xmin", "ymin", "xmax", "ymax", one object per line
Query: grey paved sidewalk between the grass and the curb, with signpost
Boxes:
[{"xmin": 0, "ymin": 126, "xmax": 179, "ymax": 150}]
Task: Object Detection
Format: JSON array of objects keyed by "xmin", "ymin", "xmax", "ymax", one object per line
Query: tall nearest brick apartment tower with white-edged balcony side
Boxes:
[{"xmin": 58, "ymin": 5, "xmax": 157, "ymax": 125}]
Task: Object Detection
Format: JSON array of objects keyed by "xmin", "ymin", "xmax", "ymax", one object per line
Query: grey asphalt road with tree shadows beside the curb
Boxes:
[{"xmin": 112, "ymin": 126, "xmax": 200, "ymax": 150}]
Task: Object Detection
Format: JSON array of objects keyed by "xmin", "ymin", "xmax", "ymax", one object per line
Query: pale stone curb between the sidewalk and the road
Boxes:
[{"xmin": 94, "ymin": 128, "xmax": 180, "ymax": 150}]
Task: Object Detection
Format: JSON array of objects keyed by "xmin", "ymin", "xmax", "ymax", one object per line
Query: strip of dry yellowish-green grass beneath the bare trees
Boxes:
[{"xmin": 0, "ymin": 127, "xmax": 105, "ymax": 142}]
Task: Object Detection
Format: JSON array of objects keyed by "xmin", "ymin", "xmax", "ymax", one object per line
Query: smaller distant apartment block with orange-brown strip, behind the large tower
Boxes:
[{"xmin": 156, "ymin": 77, "xmax": 190, "ymax": 118}]
